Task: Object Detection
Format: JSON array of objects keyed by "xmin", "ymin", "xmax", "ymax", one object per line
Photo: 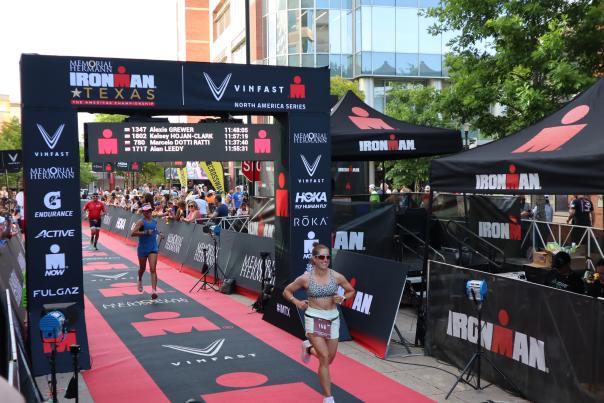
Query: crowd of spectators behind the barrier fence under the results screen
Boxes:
[{"xmin": 87, "ymin": 184, "xmax": 250, "ymax": 223}]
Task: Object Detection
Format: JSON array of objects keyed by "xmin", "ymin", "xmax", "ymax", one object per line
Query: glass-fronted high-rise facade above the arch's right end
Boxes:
[{"xmin": 260, "ymin": 0, "xmax": 451, "ymax": 81}]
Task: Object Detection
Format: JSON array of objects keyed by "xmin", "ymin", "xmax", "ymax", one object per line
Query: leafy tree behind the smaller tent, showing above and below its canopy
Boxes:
[{"xmin": 385, "ymin": 85, "xmax": 459, "ymax": 189}]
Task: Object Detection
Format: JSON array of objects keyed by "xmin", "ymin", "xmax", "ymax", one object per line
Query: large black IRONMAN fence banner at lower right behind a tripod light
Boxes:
[{"xmin": 426, "ymin": 261, "xmax": 604, "ymax": 402}]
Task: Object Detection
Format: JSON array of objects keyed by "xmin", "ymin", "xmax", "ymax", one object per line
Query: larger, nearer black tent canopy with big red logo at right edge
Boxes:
[{"xmin": 431, "ymin": 79, "xmax": 604, "ymax": 194}]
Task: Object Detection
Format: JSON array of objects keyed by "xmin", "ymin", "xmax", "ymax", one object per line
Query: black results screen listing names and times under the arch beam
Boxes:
[{"xmin": 85, "ymin": 122, "xmax": 280, "ymax": 162}]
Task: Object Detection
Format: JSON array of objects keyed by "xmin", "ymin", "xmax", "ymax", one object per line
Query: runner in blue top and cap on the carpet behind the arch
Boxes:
[{"xmin": 130, "ymin": 203, "xmax": 163, "ymax": 299}]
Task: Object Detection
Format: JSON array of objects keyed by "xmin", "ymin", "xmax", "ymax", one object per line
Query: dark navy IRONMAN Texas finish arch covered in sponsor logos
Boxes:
[{"xmin": 21, "ymin": 54, "xmax": 331, "ymax": 375}]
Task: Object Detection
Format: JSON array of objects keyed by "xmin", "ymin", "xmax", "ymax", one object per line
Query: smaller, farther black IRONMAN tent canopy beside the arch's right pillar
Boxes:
[{"xmin": 330, "ymin": 91, "xmax": 462, "ymax": 161}]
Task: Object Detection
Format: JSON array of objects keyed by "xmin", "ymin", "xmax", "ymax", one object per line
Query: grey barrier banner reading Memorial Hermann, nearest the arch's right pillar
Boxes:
[{"xmin": 220, "ymin": 231, "xmax": 275, "ymax": 293}]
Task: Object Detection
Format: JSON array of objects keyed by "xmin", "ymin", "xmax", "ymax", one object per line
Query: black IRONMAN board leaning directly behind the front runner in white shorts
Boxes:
[{"xmin": 333, "ymin": 251, "xmax": 410, "ymax": 358}]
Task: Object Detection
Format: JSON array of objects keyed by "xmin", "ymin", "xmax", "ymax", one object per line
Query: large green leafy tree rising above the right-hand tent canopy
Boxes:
[{"xmin": 427, "ymin": 0, "xmax": 604, "ymax": 138}]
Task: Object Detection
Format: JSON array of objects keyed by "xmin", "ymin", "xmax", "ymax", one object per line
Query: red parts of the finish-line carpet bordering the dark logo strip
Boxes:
[{"xmin": 84, "ymin": 228, "xmax": 431, "ymax": 402}]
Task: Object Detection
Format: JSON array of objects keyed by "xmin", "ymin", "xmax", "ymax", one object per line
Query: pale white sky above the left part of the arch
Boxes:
[{"xmin": 0, "ymin": 0, "xmax": 179, "ymax": 102}]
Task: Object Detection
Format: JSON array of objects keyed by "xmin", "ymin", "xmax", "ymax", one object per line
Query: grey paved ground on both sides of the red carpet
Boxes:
[{"xmin": 36, "ymin": 294, "xmax": 526, "ymax": 403}]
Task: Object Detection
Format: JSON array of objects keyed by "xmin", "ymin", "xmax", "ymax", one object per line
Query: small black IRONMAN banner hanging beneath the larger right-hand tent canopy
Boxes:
[{"xmin": 467, "ymin": 195, "xmax": 522, "ymax": 257}]
